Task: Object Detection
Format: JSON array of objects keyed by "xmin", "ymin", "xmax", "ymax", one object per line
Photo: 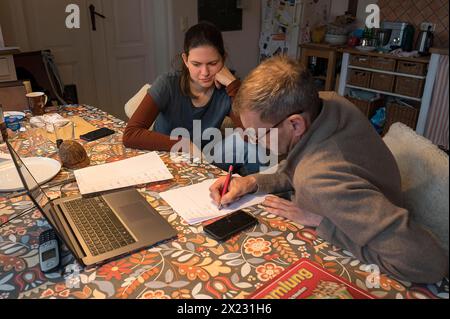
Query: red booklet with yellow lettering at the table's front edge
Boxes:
[{"xmin": 249, "ymin": 259, "xmax": 375, "ymax": 299}]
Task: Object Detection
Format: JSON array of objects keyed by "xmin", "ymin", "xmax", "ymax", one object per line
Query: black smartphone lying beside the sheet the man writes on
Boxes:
[{"xmin": 203, "ymin": 210, "xmax": 258, "ymax": 241}]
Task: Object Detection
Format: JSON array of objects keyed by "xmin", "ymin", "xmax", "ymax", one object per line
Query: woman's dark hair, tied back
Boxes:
[{"xmin": 180, "ymin": 21, "xmax": 226, "ymax": 98}]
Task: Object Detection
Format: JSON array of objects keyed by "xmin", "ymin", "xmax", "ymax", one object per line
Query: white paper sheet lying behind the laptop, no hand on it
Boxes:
[{"xmin": 74, "ymin": 152, "xmax": 173, "ymax": 195}]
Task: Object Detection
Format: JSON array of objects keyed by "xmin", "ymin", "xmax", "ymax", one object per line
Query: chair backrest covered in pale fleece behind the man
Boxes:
[{"xmin": 383, "ymin": 123, "xmax": 449, "ymax": 255}]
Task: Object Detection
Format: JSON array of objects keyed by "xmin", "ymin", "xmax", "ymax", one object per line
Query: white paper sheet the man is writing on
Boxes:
[{"xmin": 159, "ymin": 179, "xmax": 266, "ymax": 225}]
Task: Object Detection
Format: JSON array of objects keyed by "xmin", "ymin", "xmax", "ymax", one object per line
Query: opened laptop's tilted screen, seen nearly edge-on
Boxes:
[{"xmin": 6, "ymin": 142, "xmax": 50, "ymax": 212}]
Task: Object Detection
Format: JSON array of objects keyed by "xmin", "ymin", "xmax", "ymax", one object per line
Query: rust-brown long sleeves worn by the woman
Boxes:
[{"xmin": 123, "ymin": 80, "xmax": 242, "ymax": 151}]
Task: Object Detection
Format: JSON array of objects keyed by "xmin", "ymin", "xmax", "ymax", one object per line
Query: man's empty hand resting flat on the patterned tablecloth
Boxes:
[{"xmin": 263, "ymin": 195, "xmax": 323, "ymax": 227}]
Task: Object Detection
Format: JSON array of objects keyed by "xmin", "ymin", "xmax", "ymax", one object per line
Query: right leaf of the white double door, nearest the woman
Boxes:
[{"xmin": 89, "ymin": 0, "xmax": 157, "ymax": 119}]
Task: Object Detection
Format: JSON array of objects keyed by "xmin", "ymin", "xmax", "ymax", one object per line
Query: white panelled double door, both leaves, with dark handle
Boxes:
[{"xmin": 9, "ymin": 0, "xmax": 162, "ymax": 119}]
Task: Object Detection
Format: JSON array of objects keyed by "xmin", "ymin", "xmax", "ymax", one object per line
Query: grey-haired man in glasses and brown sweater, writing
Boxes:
[{"xmin": 210, "ymin": 57, "xmax": 448, "ymax": 283}]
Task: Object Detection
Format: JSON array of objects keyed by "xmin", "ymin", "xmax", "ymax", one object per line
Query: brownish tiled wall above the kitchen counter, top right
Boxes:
[{"xmin": 378, "ymin": 0, "xmax": 449, "ymax": 48}]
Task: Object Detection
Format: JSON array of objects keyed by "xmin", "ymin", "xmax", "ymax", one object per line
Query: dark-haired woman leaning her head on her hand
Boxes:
[{"xmin": 123, "ymin": 23, "xmax": 242, "ymax": 158}]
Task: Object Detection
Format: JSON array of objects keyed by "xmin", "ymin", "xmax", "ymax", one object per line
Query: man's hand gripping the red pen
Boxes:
[{"xmin": 209, "ymin": 176, "xmax": 257, "ymax": 206}]
